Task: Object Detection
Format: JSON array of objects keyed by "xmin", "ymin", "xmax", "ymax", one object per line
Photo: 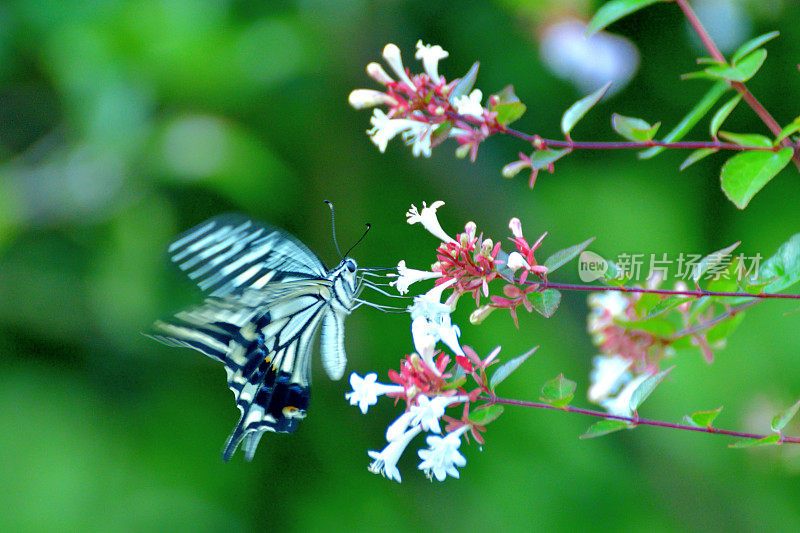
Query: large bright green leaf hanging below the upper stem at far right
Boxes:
[{"xmin": 720, "ymin": 148, "xmax": 793, "ymax": 209}]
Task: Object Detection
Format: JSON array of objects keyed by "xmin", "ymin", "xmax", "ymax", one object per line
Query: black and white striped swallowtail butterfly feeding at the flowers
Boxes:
[{"xmin": 150, "ymin": 215, "xmax": 364, "ymax": 461}]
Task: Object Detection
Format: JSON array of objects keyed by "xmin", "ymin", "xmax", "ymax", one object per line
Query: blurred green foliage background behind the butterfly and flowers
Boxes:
[{"xmin": 0, "ymin": 0, "xmax": 800, "ymax": 531}]
